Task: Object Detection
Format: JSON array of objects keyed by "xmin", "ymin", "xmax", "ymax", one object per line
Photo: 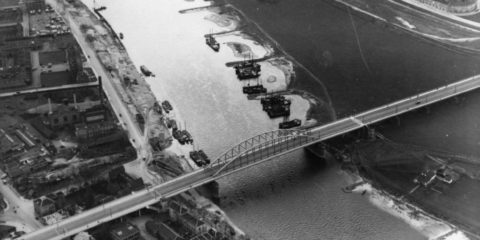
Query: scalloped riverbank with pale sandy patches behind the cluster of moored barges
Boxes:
[{"xmin": 207, "ymin": 0, "xmax": 335, "ymax": 126}]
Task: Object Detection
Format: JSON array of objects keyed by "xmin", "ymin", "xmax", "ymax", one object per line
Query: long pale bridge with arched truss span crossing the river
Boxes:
[{"xmin": 18, "ymin": 76, "xmax": 480, "ymax": 240}]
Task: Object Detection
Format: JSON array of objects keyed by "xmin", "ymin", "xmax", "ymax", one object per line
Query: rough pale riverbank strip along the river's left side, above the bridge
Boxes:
[{"xmin": 50, "ymin": 1, "xmax": 251, "ymax": 237}]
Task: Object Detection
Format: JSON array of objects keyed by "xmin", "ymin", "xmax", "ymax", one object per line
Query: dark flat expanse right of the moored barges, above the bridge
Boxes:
[{"xmin": 228, "ymin": 0, "xmax": 480, "ymax": 118}]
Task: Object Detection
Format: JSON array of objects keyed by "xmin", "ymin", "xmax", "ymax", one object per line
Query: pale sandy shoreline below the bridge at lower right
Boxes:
[{"xmin": 342, "ymin": 138, "xmax": 480, "ymax": 239}]
